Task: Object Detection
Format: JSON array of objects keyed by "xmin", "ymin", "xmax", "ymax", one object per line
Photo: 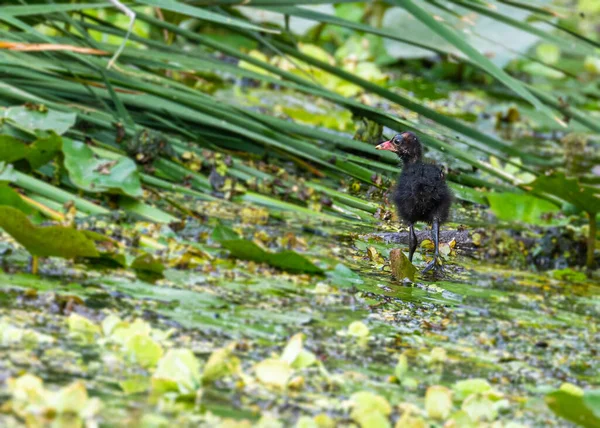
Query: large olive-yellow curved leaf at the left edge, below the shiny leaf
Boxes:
[{"xmin": 0, "ymin": 205, "xmax": 99, "ymax": 259}]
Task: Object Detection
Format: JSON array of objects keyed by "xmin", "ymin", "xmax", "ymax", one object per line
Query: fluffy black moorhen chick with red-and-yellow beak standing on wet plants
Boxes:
[{"xmin": 376, "ymin": 132, "xmax": 452, "ymax": 273}]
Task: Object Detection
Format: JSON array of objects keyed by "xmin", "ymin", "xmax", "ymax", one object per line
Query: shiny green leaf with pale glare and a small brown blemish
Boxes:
[{"xmin": 63, "ymin": 138, "xmax": 142, "ymax": 197}]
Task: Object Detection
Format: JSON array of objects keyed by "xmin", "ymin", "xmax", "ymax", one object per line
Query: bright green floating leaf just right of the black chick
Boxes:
[{"xmin": 487, "ymin": 192, "xmax": 559, "ymax": 225}]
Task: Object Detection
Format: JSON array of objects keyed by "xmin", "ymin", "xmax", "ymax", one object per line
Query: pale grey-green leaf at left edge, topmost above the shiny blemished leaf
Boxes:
[{"xmin": 0, "ymin": 107, "xmax": 77, "ymax": 135}]
